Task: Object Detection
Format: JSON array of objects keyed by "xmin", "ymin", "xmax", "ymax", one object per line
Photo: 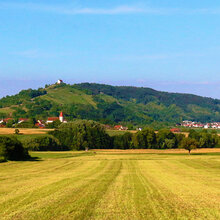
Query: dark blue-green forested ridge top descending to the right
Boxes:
[{"xmin": 77, "ymin": 83, "xmax": 220, "ymax": 111}]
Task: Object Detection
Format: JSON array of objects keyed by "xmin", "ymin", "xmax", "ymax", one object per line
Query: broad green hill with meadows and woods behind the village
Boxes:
[{"xmin": 0, "ymin": 83, "xmax": 220, "ymax": 125}]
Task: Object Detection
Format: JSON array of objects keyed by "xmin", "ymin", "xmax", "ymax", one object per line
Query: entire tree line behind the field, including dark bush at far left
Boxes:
[{"xmin": 0, "ymin": 120, "xmax": 219, "ymax": 160}]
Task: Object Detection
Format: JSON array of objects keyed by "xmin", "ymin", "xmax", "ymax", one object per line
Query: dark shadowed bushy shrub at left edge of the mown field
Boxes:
[{"xmin": 0, "ymin": 136, "xmax": 30, "ymax": 161}]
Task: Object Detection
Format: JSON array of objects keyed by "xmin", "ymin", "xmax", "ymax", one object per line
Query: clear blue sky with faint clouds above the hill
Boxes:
[{"xmin": 0, "ymin": 0, "xmax": 220, "ymax": 98}]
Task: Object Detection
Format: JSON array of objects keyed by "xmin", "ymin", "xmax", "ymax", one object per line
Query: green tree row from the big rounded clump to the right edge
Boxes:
[{"xmin": 51, "ymin": 120, "xmax": 219, "ymax": 152}]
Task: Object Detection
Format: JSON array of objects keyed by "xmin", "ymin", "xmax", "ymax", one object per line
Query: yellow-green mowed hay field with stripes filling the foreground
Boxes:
[{"xmin": 0, "ymin": 150, "xmax": 220, "ymax": 220}]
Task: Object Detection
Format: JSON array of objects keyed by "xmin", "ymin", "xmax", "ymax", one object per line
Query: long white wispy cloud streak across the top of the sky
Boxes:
[{"xmin": 0, "ymin": 2, "xmax": 220, "ymax": 15}]
